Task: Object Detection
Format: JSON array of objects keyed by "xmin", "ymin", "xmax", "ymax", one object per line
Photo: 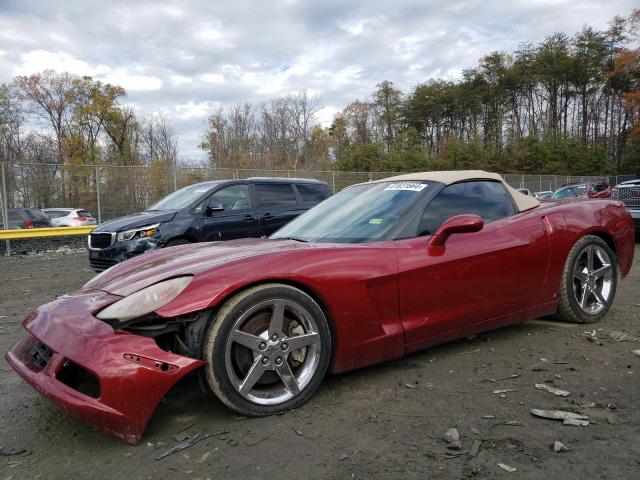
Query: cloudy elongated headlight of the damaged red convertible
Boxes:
[{"xmin": 96, "ymin": 275, "xmax": 193, "ymax": 322}]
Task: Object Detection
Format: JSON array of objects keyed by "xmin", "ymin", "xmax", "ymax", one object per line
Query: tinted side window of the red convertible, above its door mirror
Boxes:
[{"xmin": 419, "ymin": 181, "xmax": 515, "ymax": 235}]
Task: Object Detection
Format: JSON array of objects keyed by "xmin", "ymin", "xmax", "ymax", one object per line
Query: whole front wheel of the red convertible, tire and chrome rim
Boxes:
[{"xmin": 203, "ymin": 284, "xmax": 331, "ymax": 416}]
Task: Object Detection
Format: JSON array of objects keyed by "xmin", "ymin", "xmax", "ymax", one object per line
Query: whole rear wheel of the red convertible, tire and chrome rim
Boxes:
[{"xmin": 556, "ymin": 235, "xmax": 618, "ymax": 323}]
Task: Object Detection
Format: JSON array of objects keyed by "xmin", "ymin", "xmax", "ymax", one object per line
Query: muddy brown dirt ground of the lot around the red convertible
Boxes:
[{"xmin": 0, "ymin": 251, "xmax": 640, "ymax": 480}]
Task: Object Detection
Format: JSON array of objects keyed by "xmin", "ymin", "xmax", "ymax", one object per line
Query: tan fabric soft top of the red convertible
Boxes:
[{"xmin": 373, "ymin": 170, "xmax": 540, "ymax": 212}]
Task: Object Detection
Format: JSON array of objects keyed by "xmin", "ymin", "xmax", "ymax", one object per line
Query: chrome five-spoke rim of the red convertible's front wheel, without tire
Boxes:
[{"xmin": 225, "ymin": 299, "xmax": 322, "ymax": 405}]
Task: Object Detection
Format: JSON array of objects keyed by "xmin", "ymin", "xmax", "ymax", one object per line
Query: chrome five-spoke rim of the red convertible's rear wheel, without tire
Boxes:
[{"xmin": 573, "ymin": 244, "xmax": 614, "ymax": 315}]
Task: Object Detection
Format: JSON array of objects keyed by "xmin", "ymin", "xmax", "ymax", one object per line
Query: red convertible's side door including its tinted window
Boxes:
[{"xmin": 398, "ymin": 181, "xmax": 549, "ymax": 351}]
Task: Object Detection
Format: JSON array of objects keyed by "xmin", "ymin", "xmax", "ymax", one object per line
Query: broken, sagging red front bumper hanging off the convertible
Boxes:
[{"xmin": 6, "ymin": 291, "xmax": 204, "ymax": 443}]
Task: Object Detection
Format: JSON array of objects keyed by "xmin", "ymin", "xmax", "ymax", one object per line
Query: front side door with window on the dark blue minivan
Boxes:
[{"xmin": 202, "ymin": 184, "xmax": 261, "ymax": 242}]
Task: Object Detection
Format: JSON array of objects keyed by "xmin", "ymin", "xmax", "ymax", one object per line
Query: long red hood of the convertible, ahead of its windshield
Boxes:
[{"xmin": 84, "ymin": 238, "xmax": 311, "ymax": 296}]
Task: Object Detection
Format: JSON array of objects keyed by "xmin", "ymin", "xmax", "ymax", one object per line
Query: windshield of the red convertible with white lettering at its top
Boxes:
[{"xmin": 271, "ymin": 182, "xmax": 432, "ymax": 243}]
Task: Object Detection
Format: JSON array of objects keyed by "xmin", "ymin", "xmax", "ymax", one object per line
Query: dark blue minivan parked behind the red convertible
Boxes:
[{"xmin": 89, "ymin": 178, "xmax": 331, "ymax": 272}]
